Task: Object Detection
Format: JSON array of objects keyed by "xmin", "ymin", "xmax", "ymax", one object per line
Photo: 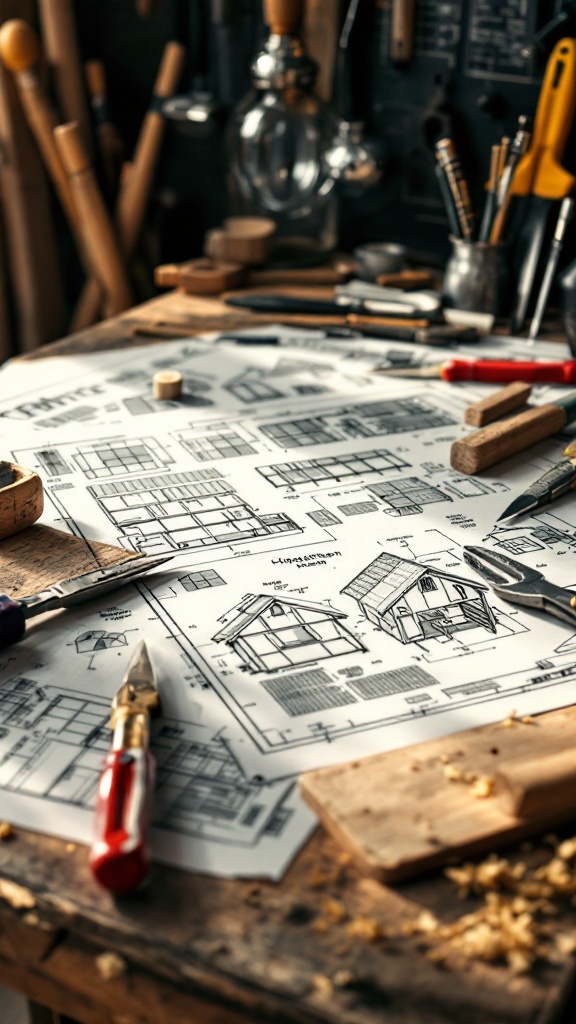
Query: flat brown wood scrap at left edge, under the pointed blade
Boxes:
[{"xmin": 0, "ymin": 523, "xmax": 137, "ymax": 597}]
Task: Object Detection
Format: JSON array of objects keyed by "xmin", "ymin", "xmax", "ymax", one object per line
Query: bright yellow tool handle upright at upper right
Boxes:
[{"xmin": 510, "ymin": 39, "xmax": 576, "ymax": 199}]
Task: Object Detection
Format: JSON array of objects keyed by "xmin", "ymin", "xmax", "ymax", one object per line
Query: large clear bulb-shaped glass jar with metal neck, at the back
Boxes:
[{"xmin": 228, "ymin": 2, "xmax": 338, "ymax": 263}]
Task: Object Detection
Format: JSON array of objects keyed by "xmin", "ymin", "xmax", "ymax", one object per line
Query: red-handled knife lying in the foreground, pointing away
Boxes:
[{"xmin": 90, "ymin": 641, "xmax": 160, "ymax": 893}]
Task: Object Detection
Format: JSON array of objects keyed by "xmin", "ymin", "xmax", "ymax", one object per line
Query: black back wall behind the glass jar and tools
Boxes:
[{"xmin": 76, "ymin": 0, "xmax": 576, "ymax": 270}]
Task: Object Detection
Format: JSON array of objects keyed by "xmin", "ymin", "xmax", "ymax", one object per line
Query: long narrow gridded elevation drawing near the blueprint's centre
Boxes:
[{"xmin": 258, "ymin": 450, "xmax": 408, "ymax": 487}]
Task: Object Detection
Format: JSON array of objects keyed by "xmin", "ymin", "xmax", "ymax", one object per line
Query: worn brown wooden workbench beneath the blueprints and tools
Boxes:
[{"xmin": 0, "ymin": 293, "xmax": 576, "ymax": 1024}]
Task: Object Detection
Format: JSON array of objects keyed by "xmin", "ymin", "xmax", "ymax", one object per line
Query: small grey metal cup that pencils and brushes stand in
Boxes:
[{"xmin": 442, "ymin": 237, "xmax": 510, "ymax": 316}]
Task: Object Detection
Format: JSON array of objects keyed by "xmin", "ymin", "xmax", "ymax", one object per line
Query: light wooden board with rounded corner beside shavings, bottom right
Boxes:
[{"xmin": 300, "ymin": 708, "xmax": 576, "ymax": 883}]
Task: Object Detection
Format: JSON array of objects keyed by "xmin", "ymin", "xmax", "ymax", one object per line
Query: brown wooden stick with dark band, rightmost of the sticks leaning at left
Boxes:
[{"xmin": 75, "ymin": 42, "xmax": 184, "ymax": 323}]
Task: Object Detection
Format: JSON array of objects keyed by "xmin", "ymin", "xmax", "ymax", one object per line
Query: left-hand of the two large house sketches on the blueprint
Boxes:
[{"xmin": 212, "ymin": 594, "xmax": 366, "ymax": 672}]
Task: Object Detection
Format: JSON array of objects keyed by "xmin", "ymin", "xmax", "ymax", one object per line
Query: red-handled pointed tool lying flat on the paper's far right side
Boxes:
[{"xmin": 372, "ymin": 359, "xmax": 576, "ymax": 384}]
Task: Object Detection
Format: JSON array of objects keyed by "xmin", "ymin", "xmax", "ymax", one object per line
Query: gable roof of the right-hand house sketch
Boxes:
[{"xmin": 342, "ymin": 552, "xmax": 488, "ymax": 613}]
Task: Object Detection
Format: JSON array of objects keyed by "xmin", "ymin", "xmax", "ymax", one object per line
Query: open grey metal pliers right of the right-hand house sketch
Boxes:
[{"xmin": 462, "ymin": 547, "xmax": 576, "ymax": 625}]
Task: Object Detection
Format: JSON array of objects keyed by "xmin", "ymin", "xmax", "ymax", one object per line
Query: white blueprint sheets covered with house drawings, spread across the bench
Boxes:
[{"xmin": 0, "ymin": 331, "xmax": 576, "ymax": 878}]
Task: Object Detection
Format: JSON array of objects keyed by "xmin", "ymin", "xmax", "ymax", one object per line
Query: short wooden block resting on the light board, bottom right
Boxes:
[{"xmin": 494, "ymin": 748, "xmax": 576, "ymax": 818}]
